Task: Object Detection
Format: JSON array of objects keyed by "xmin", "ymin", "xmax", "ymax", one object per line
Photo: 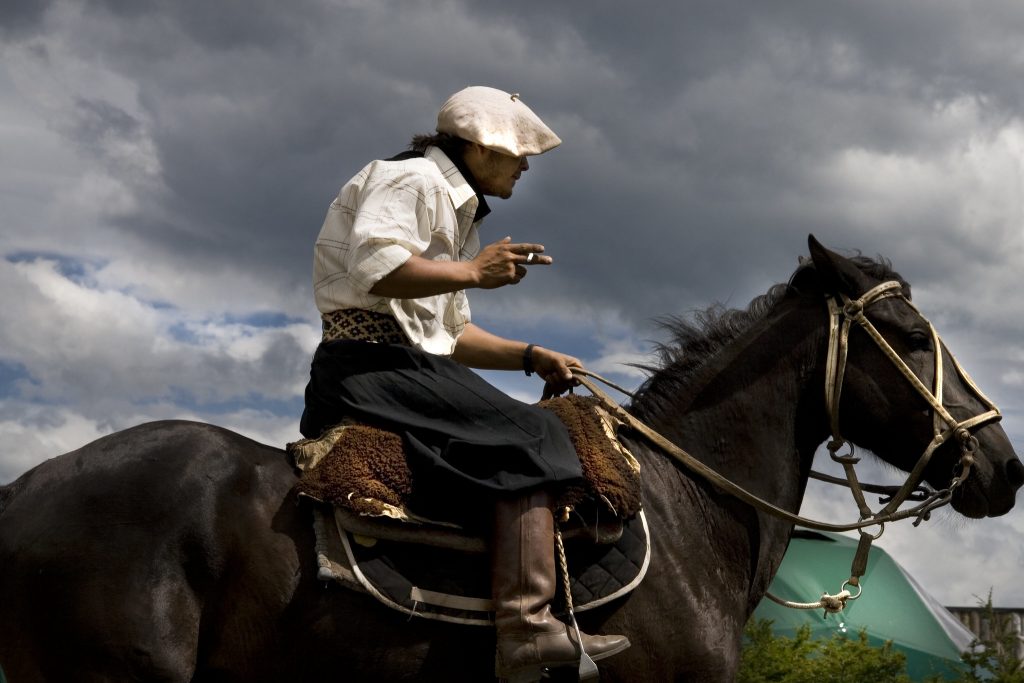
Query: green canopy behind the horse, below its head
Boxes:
[{"xmin": 754, "ymin": 529, "xmax": 974, "ymax": 681}]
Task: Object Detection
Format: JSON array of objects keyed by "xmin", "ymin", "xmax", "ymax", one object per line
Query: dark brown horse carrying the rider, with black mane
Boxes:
[{"xmin": 0, "ymin": 240, "xmax": 1024, "ymax": 683}]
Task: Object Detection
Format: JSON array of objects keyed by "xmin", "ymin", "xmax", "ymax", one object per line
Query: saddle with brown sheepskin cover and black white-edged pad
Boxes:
[{"xmin": 287, "ymin": 394, "xmax": 649, "ymax": 625}]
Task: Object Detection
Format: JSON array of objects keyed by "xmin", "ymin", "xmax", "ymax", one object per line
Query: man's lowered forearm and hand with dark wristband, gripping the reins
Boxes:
[{"xmin": 452, "ymin": 323, "xmax": 583, "ymax": 394}]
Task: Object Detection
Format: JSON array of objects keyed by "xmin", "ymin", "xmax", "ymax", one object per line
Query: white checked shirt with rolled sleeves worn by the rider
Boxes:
[{"xmin": 313, "ymin": 147, "xmax": 480, "ymax": 355}]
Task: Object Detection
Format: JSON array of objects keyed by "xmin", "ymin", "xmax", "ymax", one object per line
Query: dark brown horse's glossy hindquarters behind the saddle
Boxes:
[{"xmin": 0, "ymin": 421, "xmax": 297, "ymax": 681}]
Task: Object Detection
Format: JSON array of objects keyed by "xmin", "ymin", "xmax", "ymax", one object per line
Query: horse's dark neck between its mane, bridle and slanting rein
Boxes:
[{"xmin": 634, "ymin": 299, "xmax": 827, "ymax": 511}]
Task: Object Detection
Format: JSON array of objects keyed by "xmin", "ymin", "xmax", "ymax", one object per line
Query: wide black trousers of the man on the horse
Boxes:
[{"xmin": 300, "ymin": 340, "xmax": 583, "ymax": 507}]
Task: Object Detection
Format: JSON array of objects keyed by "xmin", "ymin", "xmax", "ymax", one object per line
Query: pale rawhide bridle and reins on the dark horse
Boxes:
[{"xmin": 572, "ymin": 281, "xmax": 1001, "ymax": 613}]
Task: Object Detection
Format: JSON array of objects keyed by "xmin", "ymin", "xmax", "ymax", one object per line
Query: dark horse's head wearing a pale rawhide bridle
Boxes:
[{"xmin": 807, "ymin": 237, "xmax": 1024, "ymax": 517}]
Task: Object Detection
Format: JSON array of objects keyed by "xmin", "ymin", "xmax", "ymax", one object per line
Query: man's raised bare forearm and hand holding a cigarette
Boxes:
[{"xmin": 370, "ymin": 238, "xmax": 551, "ymax": 299}]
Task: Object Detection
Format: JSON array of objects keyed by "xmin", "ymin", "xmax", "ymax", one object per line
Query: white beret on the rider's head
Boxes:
[{"xmin": 437, "ymin": 85, "xmax": 562, "ymax": 157}]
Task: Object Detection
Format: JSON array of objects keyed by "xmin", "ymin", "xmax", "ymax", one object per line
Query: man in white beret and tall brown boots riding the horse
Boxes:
[{"xmin": 301, "ymin": 87, "xmax": 630, "ymax": 681}]
